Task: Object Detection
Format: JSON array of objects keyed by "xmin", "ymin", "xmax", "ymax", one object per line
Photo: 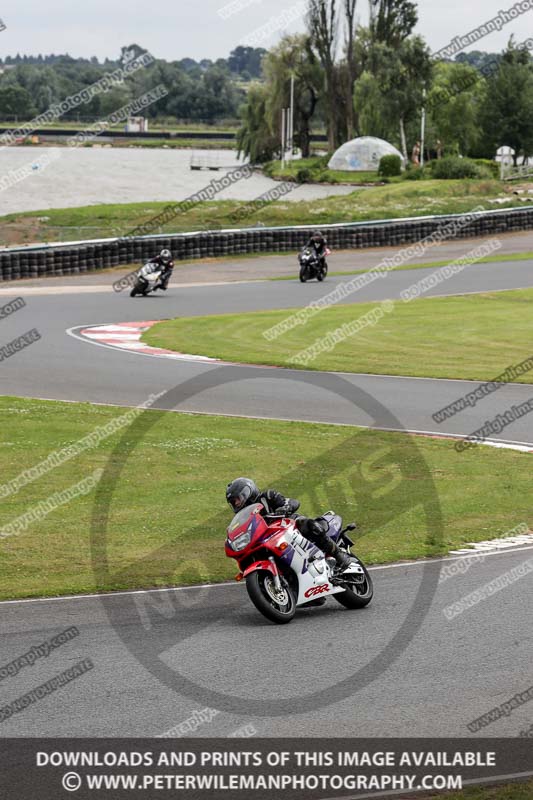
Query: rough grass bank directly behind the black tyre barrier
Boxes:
[{"xmin": 0, "ymin": 176, "xmax": 523, "ymax": 244}]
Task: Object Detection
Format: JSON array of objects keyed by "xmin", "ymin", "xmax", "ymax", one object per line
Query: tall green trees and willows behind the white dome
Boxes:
[{"xmin": 238, "ymin": 0, "xmax": 533, "ymax": 162}]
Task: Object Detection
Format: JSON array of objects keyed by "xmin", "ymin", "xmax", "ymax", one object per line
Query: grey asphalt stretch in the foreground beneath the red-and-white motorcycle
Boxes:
[{"xmin": 1, "ymin": 548, "xmax": 533, "ymax": 737}]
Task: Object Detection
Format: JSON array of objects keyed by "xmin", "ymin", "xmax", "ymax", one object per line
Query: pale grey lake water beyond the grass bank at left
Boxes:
[{"xmin": 0, "ymin": 146, "xmax": 354, "ymax": 215}]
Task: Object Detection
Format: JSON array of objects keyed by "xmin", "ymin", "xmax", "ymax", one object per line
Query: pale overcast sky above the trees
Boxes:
[{"xmin": 0, "ymin": 0, "xmax": 533, "ymax": 60}]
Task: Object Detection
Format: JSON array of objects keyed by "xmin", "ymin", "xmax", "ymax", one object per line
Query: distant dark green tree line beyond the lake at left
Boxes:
[{"xmin": 0, "ymin": 44, "xmax": 266, "ymax": 123}]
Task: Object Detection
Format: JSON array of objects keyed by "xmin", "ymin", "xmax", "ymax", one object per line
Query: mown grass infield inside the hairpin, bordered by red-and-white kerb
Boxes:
[{"xmin": 142, "ymin": 286, "xmax": 533, "ymax": 383}]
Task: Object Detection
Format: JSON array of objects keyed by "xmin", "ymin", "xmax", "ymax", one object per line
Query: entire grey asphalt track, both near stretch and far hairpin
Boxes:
[{"xmin": 0, "ymin": 255, "xmax": 533, "ymax": 737}]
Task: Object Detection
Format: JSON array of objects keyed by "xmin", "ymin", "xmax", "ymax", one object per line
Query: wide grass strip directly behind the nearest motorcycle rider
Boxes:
[{"xmin": 0, "ymin": 397, "xmax": 531, "ymax": 599}]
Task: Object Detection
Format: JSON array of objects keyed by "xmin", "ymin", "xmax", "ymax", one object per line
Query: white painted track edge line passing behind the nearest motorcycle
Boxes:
[{"xmin": 0, "ymin": 544, "xmax": 533, "ymax": 606}]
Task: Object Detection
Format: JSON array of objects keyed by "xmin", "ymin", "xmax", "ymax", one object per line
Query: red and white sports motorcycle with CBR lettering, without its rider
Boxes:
[{"xmin": 225, "ymin": 503, "xmax": 374, "ymax": 624}]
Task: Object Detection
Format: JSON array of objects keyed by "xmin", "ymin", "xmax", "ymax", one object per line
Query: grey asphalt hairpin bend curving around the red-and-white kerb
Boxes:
[{"xmin": 0, "ymin": 261, "xmax": 533, "ymax": 443}]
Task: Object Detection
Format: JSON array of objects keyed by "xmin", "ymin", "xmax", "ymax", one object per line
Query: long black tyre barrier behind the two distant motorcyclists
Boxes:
[{"xmin": 0, "ymin": 206, "xmax": 533, "ymax": 281}]
